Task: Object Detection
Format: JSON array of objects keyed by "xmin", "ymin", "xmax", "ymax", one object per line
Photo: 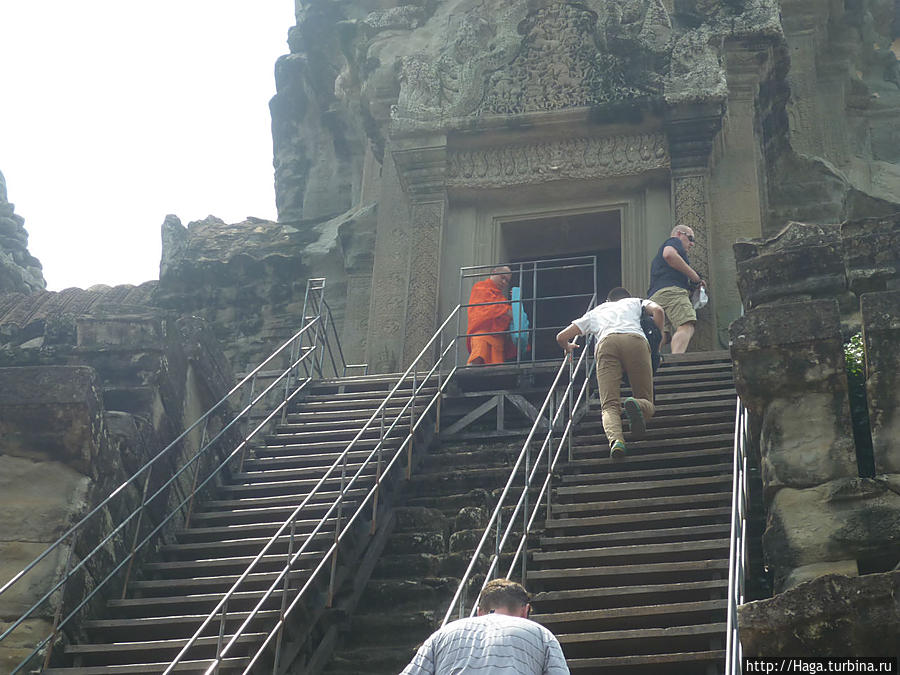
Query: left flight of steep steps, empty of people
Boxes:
[{"xmin": 45, "ymin": 375, "xmax": 434, "ymax": 675}]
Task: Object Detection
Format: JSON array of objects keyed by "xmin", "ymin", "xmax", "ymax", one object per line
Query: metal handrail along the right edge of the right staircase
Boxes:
[{"xmin": 725, "ymin": 398, "xmax": 750, "ymax": 675}]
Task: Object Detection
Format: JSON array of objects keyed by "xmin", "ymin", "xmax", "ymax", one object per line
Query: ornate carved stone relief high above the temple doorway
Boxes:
[{"xmin": 394, "ymin": 0, "xmax": 672, "ymax": 120}]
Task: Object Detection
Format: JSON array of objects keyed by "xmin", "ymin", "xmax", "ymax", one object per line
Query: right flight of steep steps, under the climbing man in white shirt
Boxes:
[{"xmin": 528, "ymin": 352, "xmax": 736, "ymax": 675}]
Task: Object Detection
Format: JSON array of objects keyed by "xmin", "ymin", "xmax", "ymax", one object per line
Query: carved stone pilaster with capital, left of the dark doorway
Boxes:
[{"xmin": 393, "ymin": 135, "xmax": 447, "ymax": 367}]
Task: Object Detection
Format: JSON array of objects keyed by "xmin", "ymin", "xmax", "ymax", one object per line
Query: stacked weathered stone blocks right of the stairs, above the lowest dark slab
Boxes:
[{"xmin": 731, "ymin": 213, "xmax": 900, "ymax": 624}]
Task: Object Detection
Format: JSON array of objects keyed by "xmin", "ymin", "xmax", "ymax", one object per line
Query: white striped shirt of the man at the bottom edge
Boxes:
[{"xmin": 401, "ymin": 614, "xmax": 569, "ymax": 675}]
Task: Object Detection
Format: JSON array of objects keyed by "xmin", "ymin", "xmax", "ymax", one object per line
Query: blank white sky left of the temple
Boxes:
[{"xmin": 0, "ymin": 0, "xmax": 294, "ymax": 290}]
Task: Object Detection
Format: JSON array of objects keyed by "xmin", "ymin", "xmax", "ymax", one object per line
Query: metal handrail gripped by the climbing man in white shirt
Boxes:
[{"xmin": 441, "ymin": 338, "xmax": 592, "ymax": 626}]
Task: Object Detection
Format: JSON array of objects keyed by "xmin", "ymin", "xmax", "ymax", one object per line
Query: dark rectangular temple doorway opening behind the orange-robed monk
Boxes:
[{"xmin": 499, "ymin": 210, "xmax": 622, "ymax": 360}]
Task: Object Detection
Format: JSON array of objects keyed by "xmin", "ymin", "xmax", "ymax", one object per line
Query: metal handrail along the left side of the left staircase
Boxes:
[{"xmin": 0, "ymin": 279, "xmax": 352, "ymax": 673}]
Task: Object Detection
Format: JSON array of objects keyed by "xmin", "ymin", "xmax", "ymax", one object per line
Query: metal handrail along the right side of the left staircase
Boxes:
[{"xmin": 163, "ymin": 305, "xmax": 472, "ymax": 675}]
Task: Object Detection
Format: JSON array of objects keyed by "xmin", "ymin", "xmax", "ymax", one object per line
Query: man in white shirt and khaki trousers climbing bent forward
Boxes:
[{"xmin": 556, "ymin": 287, "xmax": 665, "ymax": 459}]
